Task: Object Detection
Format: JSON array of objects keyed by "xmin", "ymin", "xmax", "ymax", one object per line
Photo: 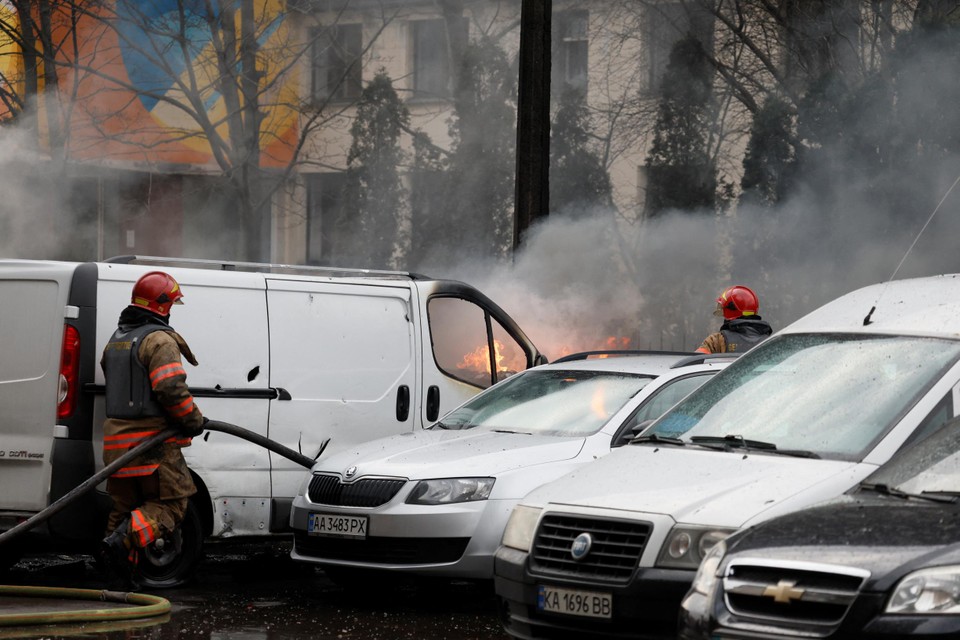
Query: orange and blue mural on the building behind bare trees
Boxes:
[{"xmin": 65, "ymin": 0, "xmax": 299, "ymax": 169}]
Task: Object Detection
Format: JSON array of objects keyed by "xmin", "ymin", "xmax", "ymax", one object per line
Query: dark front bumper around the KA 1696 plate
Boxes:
[{"xmin": 494, "ymin": 547, "xmax": 694, "ymax": 638}]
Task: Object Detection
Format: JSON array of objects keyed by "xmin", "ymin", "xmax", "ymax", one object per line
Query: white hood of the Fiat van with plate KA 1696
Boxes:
[{"xmin": 523, "ymin": 445, "xmax": 875, "ymax": 527}]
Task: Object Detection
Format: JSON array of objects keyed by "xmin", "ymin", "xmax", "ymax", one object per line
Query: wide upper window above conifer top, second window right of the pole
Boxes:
[{"xmin": 641, "ymin": 2, "xmax": 713, "ymax": 95}]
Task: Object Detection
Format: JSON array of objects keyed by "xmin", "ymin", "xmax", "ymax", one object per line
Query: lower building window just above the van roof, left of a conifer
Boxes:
[{"xmin": 307, "ymin": 172, "xmax": 346, "ymax": 265}]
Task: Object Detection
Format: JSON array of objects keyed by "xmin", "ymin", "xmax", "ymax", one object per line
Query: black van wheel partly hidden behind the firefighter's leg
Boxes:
[{"xmin": 138, "ymin": 500, "xmax": 204, "ymax": 589}]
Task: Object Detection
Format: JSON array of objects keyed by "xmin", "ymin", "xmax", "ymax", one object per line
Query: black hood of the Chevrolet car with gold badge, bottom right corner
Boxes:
[{"xmin": 727, "ymin": 494, "xmax": 960, "ymax": 588}]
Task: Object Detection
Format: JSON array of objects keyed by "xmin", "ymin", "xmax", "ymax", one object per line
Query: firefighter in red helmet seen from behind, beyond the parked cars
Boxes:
[{"xmin": 697, "ymin": 284, "xmax": 773, "ymax": 353}]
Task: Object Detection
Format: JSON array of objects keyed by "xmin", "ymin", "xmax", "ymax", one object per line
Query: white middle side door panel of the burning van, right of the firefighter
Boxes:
[{"xmin": 267, "ymin": 279, "xmax": 418, "ymax": 500}]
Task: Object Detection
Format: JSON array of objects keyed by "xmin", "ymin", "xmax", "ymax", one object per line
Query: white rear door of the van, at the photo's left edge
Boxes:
[{"xmin": 0, "ymin": 261, "xmax": 75, "ymax": 516}]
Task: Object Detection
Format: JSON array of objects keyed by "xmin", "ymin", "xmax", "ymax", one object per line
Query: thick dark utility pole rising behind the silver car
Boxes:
[{"xmin": 513, "ymin": 0, "xmax": 553, "ymax": 252}]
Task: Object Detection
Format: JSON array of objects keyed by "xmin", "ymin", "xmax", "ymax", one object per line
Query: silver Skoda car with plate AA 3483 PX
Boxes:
[{"xmin": 290, "ymin": 353, "xmax": 732, "ymax": 583}]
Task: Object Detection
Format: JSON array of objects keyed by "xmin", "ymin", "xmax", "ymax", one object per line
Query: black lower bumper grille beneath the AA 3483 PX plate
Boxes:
[{"xmin": 294, "ymin": 531, "xmax": 470, "ymax": 564}]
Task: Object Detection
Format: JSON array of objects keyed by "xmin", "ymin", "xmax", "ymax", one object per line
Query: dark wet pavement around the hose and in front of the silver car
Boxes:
[{"xmin": 0, "ymin": 541, "xmax": 508, "ymax": 640}]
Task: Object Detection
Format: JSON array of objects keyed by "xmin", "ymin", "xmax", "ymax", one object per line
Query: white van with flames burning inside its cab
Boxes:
[{"xmin": 0, "ymin": 257, "xmax": 544, "ymax": 586}]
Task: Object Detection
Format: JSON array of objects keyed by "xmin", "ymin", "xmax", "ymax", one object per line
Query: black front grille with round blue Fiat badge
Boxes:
[{"xmin": 530, "ymin": 514, "xmax": 652, "ymax": 582}]
